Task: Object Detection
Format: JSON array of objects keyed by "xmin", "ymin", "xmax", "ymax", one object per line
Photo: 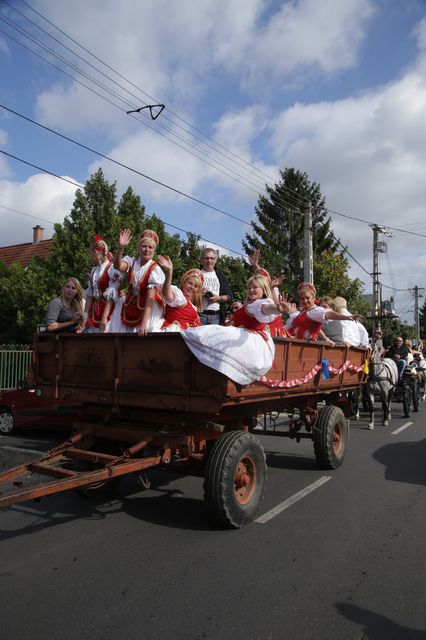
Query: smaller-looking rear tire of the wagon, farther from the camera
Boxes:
[{"xmin": 313, "ymin": 405, "xmax": 349, "ymax": 469}]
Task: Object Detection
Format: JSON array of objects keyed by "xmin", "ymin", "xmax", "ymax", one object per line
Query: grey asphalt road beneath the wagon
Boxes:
[{"xmin": 0, "ymin": 403, "xmax": 426, "ymax": 640}]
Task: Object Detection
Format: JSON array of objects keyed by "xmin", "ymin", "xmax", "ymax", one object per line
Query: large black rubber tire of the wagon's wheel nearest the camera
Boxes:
[{"xmin": 204, "ymin": 431, "xmax": 267, "ymax": 529}]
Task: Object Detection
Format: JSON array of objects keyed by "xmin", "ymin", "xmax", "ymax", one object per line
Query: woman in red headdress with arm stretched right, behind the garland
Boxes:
[{"xmin": 285, "ymin": 282, "xmax": 358, "ymax": 340}]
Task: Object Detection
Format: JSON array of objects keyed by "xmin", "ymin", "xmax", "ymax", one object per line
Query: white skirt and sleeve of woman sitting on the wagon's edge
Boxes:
[{"xmin": 181, "ymin": 298, "xmax": 276, "ymax": 385}]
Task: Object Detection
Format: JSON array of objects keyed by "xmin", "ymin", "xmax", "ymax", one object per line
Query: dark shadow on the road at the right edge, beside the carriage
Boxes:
[{"xmin": 373, "ymin": 439, "xmax": 426, "ymax": 485}]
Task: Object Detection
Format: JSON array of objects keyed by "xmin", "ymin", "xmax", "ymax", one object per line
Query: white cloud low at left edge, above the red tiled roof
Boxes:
[{"xmin": 0, "ymin": 174, "xmax": 76, "ymax": 246}]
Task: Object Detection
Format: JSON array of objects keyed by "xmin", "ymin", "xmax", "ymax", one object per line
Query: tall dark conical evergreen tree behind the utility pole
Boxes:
[{"xmin": 243, "ymin": 168, "xmax": 338, "ymax": 296}]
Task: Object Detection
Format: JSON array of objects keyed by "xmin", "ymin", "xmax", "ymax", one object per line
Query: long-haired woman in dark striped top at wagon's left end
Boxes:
[{"xmin": 45, "ymin": 278, "xmax": 84, "ymax": 333}]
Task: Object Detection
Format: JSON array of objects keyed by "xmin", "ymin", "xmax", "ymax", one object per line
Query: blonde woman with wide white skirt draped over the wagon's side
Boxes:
[{"xmin": 182, "ymin": 276, "xmax": 282, "ymax": 385}]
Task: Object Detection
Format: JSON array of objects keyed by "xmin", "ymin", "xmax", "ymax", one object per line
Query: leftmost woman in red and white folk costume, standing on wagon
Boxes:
[{"xmin": 83, "ymin": 236, "xmax": 121, "ymax": 333}]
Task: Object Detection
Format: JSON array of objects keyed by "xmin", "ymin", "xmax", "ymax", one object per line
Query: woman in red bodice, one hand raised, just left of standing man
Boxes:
[{"xmin": 157, "ymin": 256, "xmax": 204, "ymax": 332}]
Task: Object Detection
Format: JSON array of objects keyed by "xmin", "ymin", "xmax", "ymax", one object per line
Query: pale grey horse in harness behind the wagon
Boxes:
[{"xmin": 366, "ymin": 346, "xmax": 398, "ymax": 431}]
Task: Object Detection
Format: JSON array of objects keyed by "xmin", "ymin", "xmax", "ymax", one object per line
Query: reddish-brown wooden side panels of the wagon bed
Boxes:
[{"xmin": 32, "ymin": 333, "xmax": 366, "ymax": 415}]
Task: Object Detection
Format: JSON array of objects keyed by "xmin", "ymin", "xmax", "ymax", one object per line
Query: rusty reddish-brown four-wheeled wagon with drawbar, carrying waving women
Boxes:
[{"xmin": 0, "ymin": 333, "xmax": 366, "ymax": 528}]
